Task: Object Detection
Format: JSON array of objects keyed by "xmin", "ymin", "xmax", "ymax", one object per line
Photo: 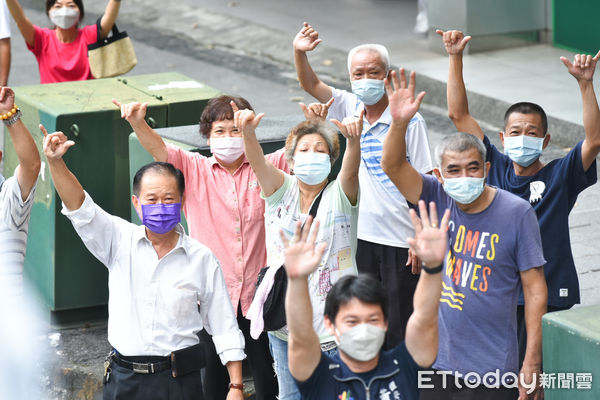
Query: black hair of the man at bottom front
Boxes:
[{"xmin": 324, "ymin": 274, "xmax": 388, "ymax": 323}]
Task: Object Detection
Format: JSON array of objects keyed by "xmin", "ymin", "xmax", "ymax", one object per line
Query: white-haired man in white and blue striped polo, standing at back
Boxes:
[{"xmin": 293, "ymin": 23, "xmax": 432, "ymax": 349}]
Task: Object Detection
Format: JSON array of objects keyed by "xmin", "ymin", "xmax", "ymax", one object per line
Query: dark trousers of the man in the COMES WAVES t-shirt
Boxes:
[{"xmin": 419, "ymin": 374, "xmax": 519, "ymax": 400}]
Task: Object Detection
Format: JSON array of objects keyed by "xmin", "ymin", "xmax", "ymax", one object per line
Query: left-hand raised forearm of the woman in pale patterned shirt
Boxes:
[{"xmin": 231, "ymin": 101, "xmax": 283, "ymax": 197}]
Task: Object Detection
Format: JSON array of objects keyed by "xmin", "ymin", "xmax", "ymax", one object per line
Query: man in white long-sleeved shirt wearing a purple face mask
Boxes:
[{"xmin": 43, "ymin": 129, "xmax": 245, "ymax": 400}]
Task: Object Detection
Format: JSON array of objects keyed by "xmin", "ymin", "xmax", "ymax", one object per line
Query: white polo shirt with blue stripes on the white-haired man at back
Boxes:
[{"xmin": 329, "ymin": 88, "xmax": 433, "ymax": 248}]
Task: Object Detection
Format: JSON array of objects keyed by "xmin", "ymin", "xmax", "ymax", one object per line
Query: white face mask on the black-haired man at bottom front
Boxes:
[{"xmin": 335, "ymin": 324, "xmax": 385, "ymax": 361}]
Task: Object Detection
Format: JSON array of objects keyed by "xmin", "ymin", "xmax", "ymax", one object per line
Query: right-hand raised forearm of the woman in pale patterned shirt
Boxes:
[{"xmin": 331, "ymin": 109, "xmax": 365, "ymax": 205}]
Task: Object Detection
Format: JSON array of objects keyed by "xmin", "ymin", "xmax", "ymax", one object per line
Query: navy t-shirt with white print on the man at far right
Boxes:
[{"xmin": 483, "ymin": 137, "xmax": 598, "ymax": 307}]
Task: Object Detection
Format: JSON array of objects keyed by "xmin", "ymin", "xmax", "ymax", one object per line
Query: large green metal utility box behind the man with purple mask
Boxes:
[{"xmin": 4, "ymin": 73, "xmax": 218, "ymax": 324}]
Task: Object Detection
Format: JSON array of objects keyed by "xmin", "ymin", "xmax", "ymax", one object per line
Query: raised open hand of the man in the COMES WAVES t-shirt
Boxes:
[{"xmin": 384, "ymin": 68, "xmax": 425, "ymax": 121}]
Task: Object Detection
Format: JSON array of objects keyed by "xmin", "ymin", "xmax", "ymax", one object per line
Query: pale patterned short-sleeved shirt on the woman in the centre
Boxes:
[{"xmin": 265, "ymin": 174, "xmax": 358, "ymax": 343}]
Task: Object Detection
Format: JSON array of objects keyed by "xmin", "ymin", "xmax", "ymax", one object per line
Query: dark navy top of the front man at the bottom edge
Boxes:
[{"xmin": 297, "ymin": 342, "xmax": 419, "ymax": 400}]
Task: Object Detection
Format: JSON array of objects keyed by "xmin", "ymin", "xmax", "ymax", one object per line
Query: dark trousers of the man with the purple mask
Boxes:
[{"xmin": 102, "ymin": 360, "xmax": 204, "ymax": 400}]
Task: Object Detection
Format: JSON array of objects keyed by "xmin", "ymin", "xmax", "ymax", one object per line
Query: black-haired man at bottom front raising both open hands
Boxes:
[{"xmin": 282, "ymin": 202, "xmax": 450, "ymax": 400}]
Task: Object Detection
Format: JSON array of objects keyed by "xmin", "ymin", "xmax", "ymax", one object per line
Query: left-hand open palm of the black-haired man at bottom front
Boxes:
[{"xmin": 279, "ymin": 215, "xmax": 327, "ymax": 278}]
